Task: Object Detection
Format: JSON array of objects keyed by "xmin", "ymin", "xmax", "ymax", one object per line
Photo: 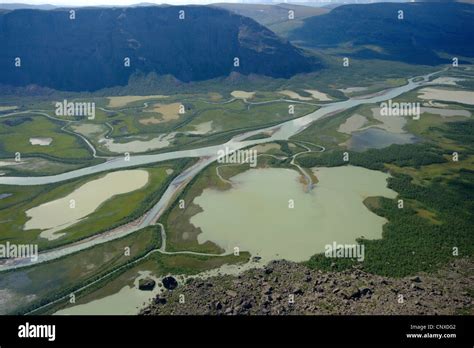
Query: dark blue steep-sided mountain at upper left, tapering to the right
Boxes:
[{"xmin": 0, "ymin": 6, "xmax": 318, "ymax": 91}]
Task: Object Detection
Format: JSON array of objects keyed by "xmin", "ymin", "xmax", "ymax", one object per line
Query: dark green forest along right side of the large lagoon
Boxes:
[{"xmin": 307, "ymin": 171, "xmax": 474, "ymax": 276}]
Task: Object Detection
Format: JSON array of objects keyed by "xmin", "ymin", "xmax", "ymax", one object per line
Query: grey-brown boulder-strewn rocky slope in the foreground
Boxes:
[{"xmin": 140, "ymin": 260, "xmax": 474, "ymax": 315}]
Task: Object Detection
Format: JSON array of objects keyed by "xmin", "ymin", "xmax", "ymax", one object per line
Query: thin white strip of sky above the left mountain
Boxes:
[{"xmin": 0, "ymin": 0, "xmax": 244, "ymax": 7}]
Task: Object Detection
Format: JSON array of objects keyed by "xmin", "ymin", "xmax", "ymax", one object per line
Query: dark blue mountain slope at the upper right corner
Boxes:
[{"xmin": 289, "ymin": 2, "xmax": 474, "ymax": 65}]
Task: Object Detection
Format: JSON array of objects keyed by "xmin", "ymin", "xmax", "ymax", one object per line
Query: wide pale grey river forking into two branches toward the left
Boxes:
[{"xmin": 0, "ymin": 71, "xmax": 439, "ymax": 271}]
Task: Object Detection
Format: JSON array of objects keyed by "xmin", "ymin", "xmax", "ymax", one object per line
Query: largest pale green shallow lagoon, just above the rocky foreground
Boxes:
[{"xmin": 191, "ymin": 166, "xmax": 396, "ymax": 261}]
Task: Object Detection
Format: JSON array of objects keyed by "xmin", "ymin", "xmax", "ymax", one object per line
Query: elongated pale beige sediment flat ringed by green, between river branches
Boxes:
[{"xmin": 23, "ymin": 170, "xmax": 149, "ymax": 240}]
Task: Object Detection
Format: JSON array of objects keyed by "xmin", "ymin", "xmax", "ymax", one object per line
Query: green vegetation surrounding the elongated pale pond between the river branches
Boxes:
[{"xmin": 0, "ymin": 159, "xmax": 191, "ymax": 250}]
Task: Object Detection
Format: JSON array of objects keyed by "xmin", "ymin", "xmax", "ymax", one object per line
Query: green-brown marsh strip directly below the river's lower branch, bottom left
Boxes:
[{"xmin": 0, "ymin": 227, "xmax": 161, "ymax": 314}]
